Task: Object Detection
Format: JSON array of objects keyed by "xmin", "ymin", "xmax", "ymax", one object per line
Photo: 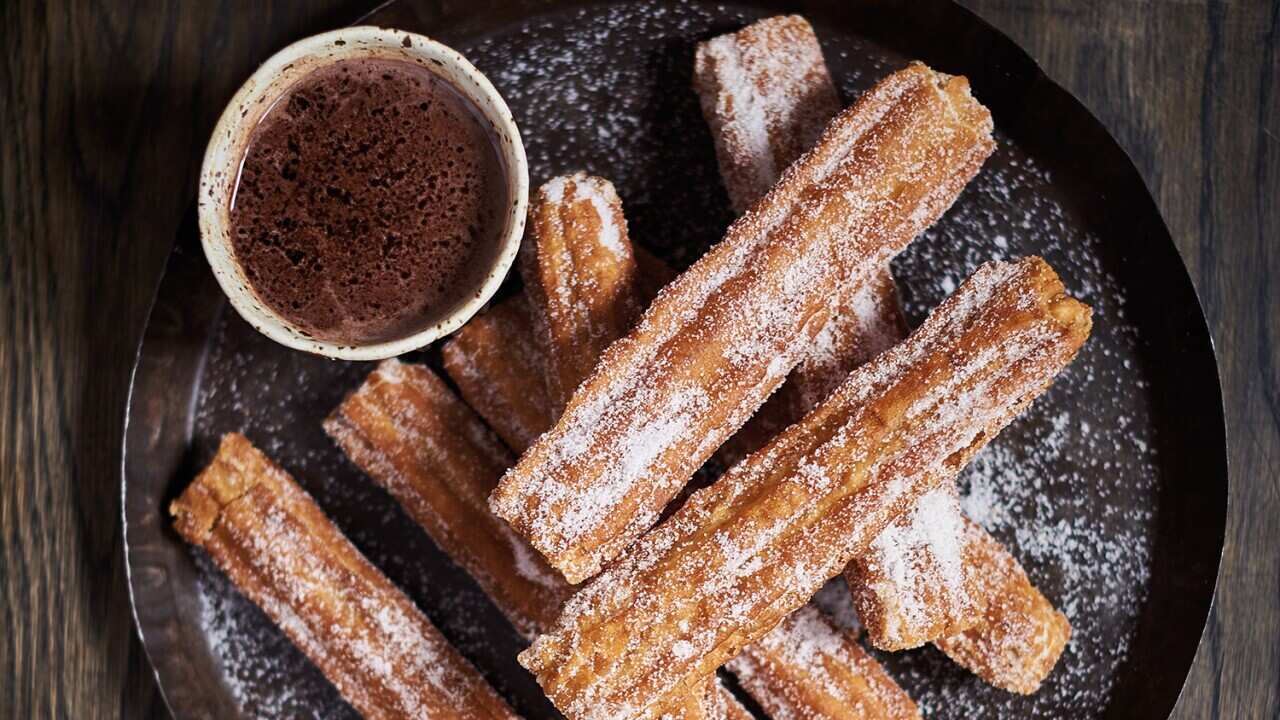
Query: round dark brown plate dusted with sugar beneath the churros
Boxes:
[{"xmin": 123, "ymin": 0, "xmax": 1228, "ymax": 717}]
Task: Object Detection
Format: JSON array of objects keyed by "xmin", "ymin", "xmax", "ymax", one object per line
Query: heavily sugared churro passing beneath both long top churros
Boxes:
[{"xmin": 694, "ymin": 15, "xmax": 1059, "ymax": 681}]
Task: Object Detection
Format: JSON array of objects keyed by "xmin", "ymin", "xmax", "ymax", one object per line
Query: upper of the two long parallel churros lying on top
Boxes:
[{"xmin": 490, "ymin": 64, "xmax": 993, "ymax": 583}]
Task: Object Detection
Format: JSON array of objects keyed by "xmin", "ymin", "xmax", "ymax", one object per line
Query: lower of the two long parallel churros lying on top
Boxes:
[{"xmin": 520, "ymin": 258, "xmax": 1089, "ymax": 720}]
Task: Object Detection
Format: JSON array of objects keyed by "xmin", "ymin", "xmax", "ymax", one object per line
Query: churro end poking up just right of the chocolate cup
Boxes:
[{"xmin": 521, "ymin": 173, "xmax": 641, "ymax": 414}]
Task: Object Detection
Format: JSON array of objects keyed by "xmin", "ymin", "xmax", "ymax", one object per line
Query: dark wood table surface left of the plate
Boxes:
[{"xmin": 0, "ymin": 0, "xmax": 367, "ymax": 719}]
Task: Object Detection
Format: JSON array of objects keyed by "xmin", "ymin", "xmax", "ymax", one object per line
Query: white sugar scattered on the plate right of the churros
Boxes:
[{"xmin": 882, "ymin": 138, "xmax": 1157, "ymax": 717}]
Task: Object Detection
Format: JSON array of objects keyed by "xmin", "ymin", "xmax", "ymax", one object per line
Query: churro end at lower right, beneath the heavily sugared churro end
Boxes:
[{"xmin": 933, "ymin": 520, "xmax": 1071, "ymax": 694}]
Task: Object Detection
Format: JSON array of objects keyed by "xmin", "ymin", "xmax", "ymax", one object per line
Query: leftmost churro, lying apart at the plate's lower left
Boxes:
[{"xmin": 169, "ymin": 433, "xmax": 516, "ymax": 720}]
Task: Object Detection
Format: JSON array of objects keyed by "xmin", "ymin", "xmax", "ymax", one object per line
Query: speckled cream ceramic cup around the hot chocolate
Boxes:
[{"xmin": 198, "ymin": 26, "xmax": 529, "ymax": 360}]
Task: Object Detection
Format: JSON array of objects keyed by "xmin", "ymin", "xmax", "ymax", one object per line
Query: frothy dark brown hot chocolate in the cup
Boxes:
[{"xmin": 229, "ymin": 59, "xmax": 508, "ymax": 343}]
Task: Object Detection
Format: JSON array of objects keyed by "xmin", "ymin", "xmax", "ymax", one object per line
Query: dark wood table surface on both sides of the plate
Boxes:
[{"xmin": 0, "ymin": 0, "xmax": 1280, "ymax": 719}]
